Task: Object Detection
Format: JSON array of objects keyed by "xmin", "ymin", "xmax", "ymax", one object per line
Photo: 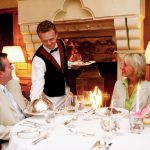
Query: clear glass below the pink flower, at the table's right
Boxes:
[{"xmin": 129, "ymin": 112, "xmax": 144, "ymax": 134}]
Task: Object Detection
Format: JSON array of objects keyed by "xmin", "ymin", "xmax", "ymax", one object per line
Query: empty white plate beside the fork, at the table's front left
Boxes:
[{"xmin": 17, "ymin": 130, "xmax": 40, "ymax": 139}]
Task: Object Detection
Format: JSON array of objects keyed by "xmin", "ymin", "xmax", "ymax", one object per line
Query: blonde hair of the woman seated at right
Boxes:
[{"xmin": 124, "ymin": 53, "xmax": 146, "ymax": 80}]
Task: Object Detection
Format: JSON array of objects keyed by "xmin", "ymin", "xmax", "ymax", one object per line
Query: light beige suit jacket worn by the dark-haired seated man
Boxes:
[{"xmin": 0, "ymin": 80, "xmax": 25, "ymax": 140}]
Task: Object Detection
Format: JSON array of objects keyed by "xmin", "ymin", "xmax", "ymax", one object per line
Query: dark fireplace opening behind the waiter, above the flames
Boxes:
[{"xmin": 64, "ymin": 36, "xmax": 117, "ymax": 105}]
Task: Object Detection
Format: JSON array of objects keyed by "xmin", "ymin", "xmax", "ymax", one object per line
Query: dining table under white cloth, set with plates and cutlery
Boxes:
[{"xmin": 7, "ymin": 108, "xmax": 150, "ymax": 150}]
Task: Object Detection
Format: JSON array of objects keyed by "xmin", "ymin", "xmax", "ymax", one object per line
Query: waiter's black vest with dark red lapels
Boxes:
[{"xmin": 34, "ymin": 40, "xmax": 69, "ymax": 97}]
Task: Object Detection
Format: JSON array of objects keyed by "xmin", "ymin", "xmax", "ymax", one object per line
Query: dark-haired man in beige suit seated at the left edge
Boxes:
[{"xmin": 0, "ymin": 53, "xmax": 26, "ymax": 150}]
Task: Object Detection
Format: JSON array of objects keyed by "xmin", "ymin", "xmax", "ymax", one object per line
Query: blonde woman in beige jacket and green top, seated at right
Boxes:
[{"xmin": 111, "ymin": 53, "xmax": 150, "ymax": 111}]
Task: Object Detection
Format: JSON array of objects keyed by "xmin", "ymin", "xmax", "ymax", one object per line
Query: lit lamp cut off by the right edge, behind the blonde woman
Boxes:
[{"xmin": 145, "ymin": 42, "xmax": 150, "ymax": 81}]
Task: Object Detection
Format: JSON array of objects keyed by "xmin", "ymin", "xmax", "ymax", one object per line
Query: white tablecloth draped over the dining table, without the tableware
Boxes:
[{"xmin": 7, "ymin": 110, "xmax": 150, "ymax": 150}]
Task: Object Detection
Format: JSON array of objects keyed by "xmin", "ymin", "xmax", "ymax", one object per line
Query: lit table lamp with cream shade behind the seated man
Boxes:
[{"xmin": 2, "ymin": 46, "xmax": 25, "ymax": 80}]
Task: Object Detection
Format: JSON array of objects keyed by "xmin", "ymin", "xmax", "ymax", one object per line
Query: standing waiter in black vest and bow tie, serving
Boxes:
[{"xmin": 30, "ymin": 20, "xmax": 71, "ymax": 108}]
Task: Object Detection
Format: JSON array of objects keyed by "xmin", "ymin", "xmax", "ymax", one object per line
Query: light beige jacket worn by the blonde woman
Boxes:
[{"xmin": 111, "ymin": 80, "xmax": 150, "ymax": 111}]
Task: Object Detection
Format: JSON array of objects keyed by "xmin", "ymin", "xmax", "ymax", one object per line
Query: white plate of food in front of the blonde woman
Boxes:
[{"xmin": 95, "ymin": 107, "xmax": 129, "ymax": 120}]
